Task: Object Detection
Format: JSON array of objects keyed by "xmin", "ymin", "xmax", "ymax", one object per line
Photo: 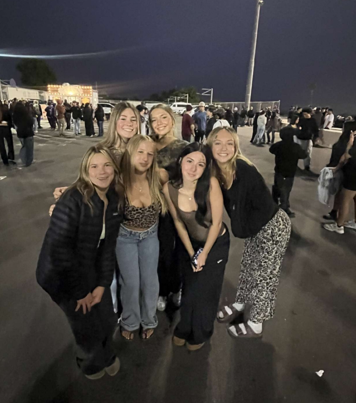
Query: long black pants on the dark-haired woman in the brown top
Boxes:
[{"xmin": 174, "ymin": 229, "xmax": 230, "ymax": 344}]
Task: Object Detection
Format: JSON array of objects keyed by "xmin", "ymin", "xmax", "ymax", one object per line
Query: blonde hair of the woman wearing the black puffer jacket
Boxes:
[{"xmin": 67, "ymin": 143, "xmax": 122, "ymax": 213}]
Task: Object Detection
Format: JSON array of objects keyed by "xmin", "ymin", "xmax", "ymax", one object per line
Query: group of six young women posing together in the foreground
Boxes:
[{"xmin": 37, "ymin": 102, "xmax": 291, "ymax": 379}]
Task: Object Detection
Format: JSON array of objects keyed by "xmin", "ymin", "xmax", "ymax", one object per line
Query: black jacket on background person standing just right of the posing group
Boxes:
[{"xmin": 269, "ymin": 126, "xmax": 308, "ymax": 178}]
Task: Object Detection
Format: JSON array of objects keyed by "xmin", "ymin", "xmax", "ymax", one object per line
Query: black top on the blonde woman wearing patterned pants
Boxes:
[{"xmin": 223, "ymin": 160, "xmax": 278, "ymax": 238}]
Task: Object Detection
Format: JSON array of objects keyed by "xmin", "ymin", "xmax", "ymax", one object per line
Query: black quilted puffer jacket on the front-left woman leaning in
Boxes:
[{"xmin": 36, "ymin": 189, "xmax": 122, "ymax": 303}]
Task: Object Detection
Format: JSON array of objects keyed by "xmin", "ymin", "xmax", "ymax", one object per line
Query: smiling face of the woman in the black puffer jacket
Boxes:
[{"xmin": 88, "ymin": 153, "xmax": 115, "ymax": 190}]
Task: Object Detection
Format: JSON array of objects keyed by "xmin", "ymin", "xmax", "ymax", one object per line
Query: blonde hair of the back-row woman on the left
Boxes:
[{"xmin": 101, "ymin": 102, "xmax": 141, "ymax": 152}]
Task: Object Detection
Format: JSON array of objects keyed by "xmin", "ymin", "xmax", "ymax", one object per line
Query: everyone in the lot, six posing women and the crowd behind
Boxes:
[{"xmin": 0, "ymin": 101, "xmax": 356, "ymax": 379}]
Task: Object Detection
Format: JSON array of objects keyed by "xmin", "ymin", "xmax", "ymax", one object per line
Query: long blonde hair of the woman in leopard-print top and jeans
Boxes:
[{"xmin": 120, "ymin": 135, "xmax": 167, "ymax": 214}]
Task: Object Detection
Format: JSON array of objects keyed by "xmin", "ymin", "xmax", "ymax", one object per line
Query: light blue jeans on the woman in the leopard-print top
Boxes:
[{"xmin": 112, "ymin": 223, "xmax": 159, "ymax": 331}]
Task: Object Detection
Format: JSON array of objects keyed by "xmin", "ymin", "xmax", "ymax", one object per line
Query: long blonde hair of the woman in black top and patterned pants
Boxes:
[{"xmin": 206, "ymin": 127, "xmax": 254, "ymax": 187}]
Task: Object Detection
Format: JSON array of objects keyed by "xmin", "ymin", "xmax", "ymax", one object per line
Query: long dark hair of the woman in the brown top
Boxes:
[{"xmin": 171, "ymin": 143, "xmax": 213, "ymax": 228}]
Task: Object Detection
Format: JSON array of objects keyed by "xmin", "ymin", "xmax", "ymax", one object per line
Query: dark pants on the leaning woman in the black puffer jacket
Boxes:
[{"xmin": 58, "ymin": 289, "xmax": 117, "ymax": 375}]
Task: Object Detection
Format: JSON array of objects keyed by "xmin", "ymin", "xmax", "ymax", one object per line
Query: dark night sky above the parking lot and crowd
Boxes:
[{"xmin": 0, "ymin": 0, "xmax": 356, "ymax": 113}]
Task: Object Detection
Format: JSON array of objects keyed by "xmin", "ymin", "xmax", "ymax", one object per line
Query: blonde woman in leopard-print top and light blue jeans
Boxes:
[{"xmin": 114, "ymin": 135, "xmax": 166, "ymax": 340}]
